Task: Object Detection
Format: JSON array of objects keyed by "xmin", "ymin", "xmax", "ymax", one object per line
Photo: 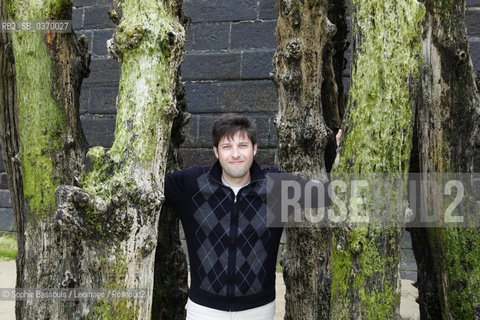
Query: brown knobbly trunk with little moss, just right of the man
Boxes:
[{"xmin": 273, "ymin": 0, "xmax": 344, "ymax": 320}]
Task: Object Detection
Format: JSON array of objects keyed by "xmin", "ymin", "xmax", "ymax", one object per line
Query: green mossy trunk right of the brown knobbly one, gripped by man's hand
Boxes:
[{"xmin": 330, "ymin": 0, "xmax": 424, "ymax": 319}]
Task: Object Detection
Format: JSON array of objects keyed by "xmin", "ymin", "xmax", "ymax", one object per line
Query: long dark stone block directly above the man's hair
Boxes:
[{"xmin": 185, "ymin": 80, "xmax": 278, "ymax": 113}]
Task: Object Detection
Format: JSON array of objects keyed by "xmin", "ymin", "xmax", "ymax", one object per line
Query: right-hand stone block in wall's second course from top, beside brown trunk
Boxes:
[{"xmin": 230, "ymin": 20, "xmax": 277, "ymax": 49}]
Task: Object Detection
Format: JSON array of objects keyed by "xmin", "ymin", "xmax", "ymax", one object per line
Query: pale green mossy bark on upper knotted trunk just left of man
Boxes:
[{"xmin": 84, "ymin": 0, "xmax": 183, "ymax": 200}]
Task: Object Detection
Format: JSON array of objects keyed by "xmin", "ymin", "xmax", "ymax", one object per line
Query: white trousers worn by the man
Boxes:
[{"xmin": 186, "ymin": 299, "xmax": 275, "ymax": 320}]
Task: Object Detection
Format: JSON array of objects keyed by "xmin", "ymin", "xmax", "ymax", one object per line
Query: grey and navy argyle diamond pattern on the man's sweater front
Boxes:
[{"xmin": 192, "ymin": 175, "xmax": 271, "ymax": 296}]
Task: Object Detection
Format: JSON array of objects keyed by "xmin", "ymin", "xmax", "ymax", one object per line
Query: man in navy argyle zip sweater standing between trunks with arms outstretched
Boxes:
[{"xmin": 165, "ymin": 115, "xmax": 342, "ymax": 320}]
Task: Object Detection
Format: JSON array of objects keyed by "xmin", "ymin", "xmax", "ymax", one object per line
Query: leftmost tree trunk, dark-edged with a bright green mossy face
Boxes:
[{"xmin": 1, "ymin": 1, "xmax": 90, "ymax": 319}]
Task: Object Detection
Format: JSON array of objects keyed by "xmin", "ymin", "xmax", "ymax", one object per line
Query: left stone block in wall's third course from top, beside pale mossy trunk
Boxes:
[{"xmin": 182, "ymin": 52, "xmax": 241, "ymax": 80}]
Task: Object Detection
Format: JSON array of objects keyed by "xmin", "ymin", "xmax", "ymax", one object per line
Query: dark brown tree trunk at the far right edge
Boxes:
[{"xmin": 411, "ymin": 0, "xmax": 480, "ymax": 319}]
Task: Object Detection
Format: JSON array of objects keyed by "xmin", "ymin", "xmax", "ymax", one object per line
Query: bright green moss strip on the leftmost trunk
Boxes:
[{"xmin": 9, "ymin": 0, "xmax": 72, "ymax": 217}]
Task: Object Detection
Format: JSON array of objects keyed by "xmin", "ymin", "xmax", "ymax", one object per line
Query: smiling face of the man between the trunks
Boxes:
[{"xmin": 213, "ymin": 131, "xmax": 257, "ymax": 186}]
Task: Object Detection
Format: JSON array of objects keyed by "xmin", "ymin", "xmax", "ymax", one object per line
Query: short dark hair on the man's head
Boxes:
[{"xmin": 212, "ymin": 114, "xmax": 257, "ymax": 147}]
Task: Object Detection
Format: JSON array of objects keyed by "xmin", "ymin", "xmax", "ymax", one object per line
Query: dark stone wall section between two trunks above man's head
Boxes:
[{"xmin": 181, "ymin": 0, "xmax": 277, "ymax": 167}]
